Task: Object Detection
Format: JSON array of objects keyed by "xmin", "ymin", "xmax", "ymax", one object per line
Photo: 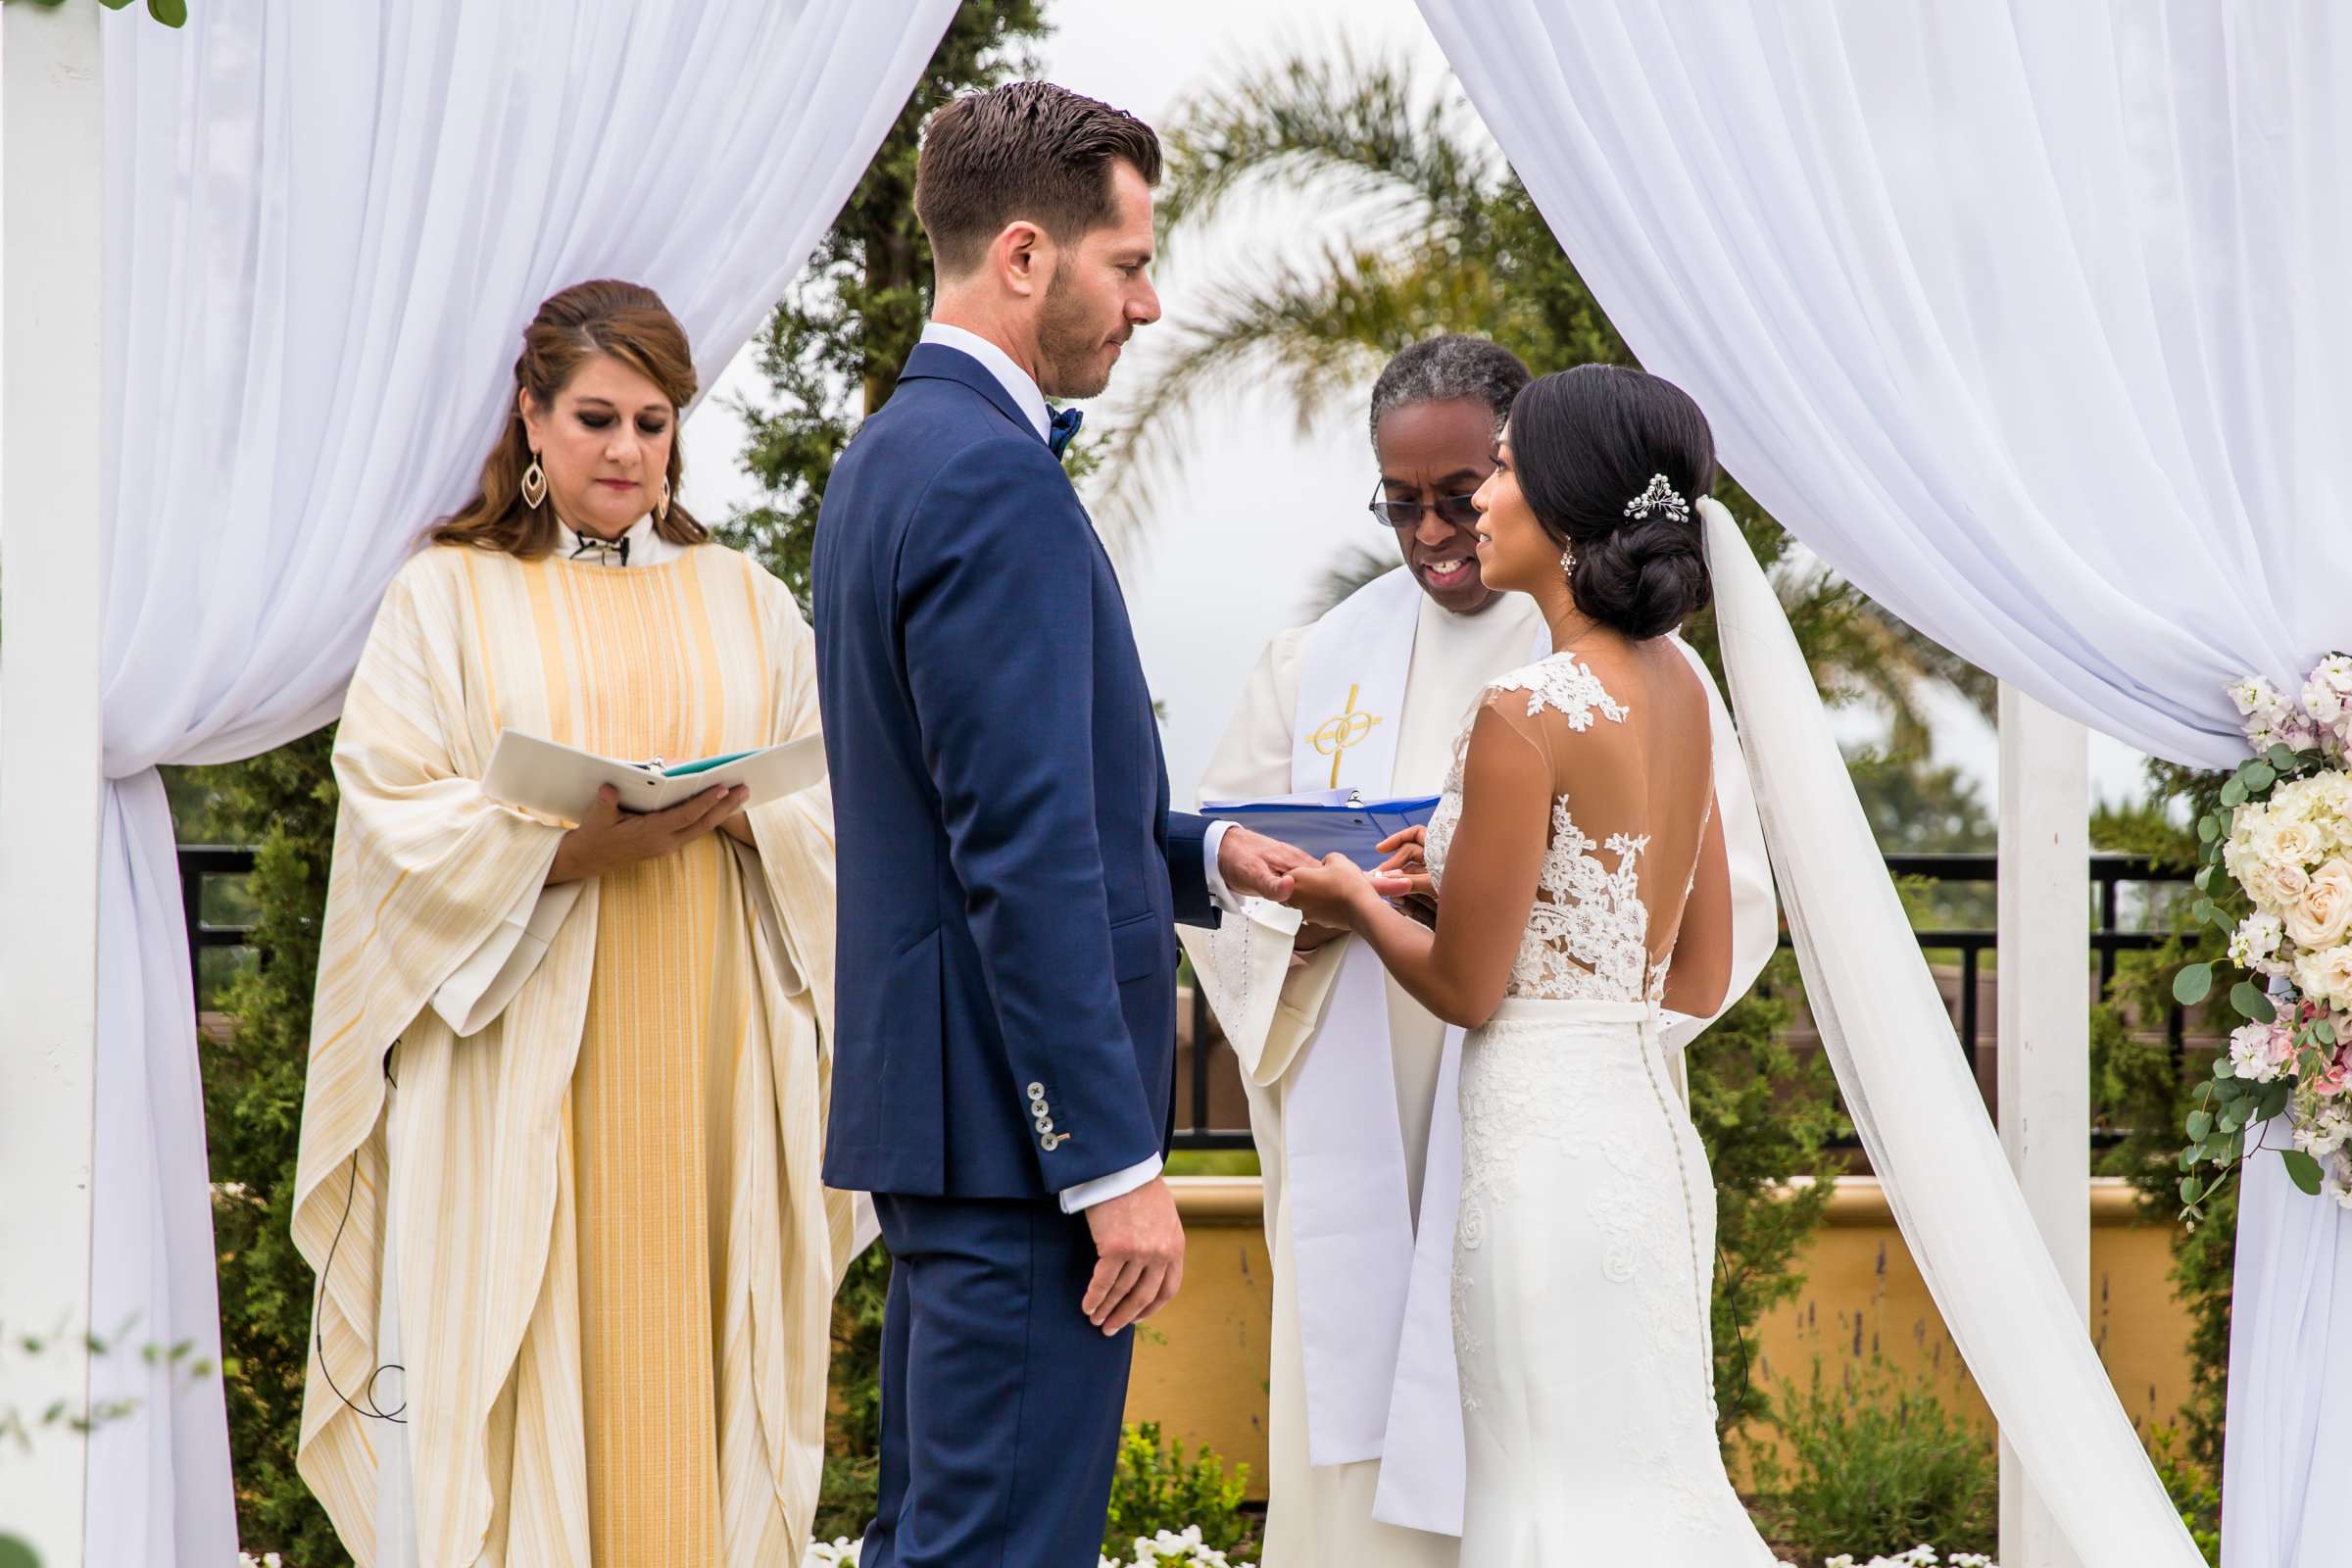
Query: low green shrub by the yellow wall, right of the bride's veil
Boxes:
[{"xmin": 1752, "ymin": 1351, "xmax": 2001, "ymax": 1561}]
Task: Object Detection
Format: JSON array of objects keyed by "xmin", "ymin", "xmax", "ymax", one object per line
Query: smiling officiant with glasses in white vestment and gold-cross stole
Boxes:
[{"xmin": 1181, "ymin": 336, "xmax": 1778, "ymax": 1568}]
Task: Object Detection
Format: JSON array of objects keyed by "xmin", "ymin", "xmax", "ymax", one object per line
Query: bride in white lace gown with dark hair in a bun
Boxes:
[{"xmin": 1294, "ymin": 367, "xmax": 1774, "ymax": 1568}]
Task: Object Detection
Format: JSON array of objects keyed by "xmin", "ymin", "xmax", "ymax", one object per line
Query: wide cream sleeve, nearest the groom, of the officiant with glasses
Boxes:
[{"xmin": 1176, "ymin": 627, "xmax": 1350, "ymax": 1084}]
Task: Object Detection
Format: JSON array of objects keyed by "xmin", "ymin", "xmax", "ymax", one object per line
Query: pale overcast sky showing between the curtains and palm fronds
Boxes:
[{"xmin": 684, "ymin": 0, "xmax": 2140, "ymax": 822}]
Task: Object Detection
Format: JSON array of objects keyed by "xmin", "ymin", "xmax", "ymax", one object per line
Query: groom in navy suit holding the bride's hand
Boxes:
[{"xmin": 816, "ymin": 82, "xmax": 1310, "ymax": 1568}]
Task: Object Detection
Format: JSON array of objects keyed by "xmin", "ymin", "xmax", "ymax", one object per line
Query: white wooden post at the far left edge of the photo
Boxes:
[{"xmin": 0, "ymin": 0, "xmax": 104, "ymax": 1568}]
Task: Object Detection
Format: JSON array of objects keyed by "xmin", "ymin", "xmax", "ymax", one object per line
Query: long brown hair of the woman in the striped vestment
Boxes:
[{"xmin": 433, "ymin": 279, "xmax": 710, "ymax": 560}]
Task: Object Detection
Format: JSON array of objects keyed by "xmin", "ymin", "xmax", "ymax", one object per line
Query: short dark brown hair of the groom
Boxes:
[{"xmin": 915, "ymin": 82, "xmax": 1159, "ymax": 277}]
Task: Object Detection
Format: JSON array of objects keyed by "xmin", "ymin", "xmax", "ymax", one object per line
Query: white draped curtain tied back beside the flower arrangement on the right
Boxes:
[{"xmin": 1421, "ymin": 0, "xmax": 2352, "ymax": 1568}]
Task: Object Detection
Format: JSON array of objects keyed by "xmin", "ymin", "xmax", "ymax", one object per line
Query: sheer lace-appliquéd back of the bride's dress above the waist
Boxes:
[{"xmin": 1428, "ymin": 644, "xmax": 1712, "ymax": 1004}]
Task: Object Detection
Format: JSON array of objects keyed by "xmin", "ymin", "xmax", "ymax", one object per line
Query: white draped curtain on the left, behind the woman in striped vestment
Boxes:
[{"xmin": 87, "ymin": 0, "xmax": 955, "ymax": 1568}]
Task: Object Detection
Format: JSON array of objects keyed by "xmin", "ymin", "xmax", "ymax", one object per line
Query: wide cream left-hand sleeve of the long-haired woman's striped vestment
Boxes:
[{"xmin": 292, "ymin": 553, "xmax": 595, "ymax": 1561}]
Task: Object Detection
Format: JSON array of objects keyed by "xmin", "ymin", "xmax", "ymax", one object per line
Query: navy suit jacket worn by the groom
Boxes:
[{"xmin": 813, "ymin": 343, "xmax": 1216, "ymax": 1197}]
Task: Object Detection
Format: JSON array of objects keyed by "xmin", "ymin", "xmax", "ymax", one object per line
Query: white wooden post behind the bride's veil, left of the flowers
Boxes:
[{"xmin": 1997, "ymin": 682, "xmax": 2091, "ymax": 1568}]
